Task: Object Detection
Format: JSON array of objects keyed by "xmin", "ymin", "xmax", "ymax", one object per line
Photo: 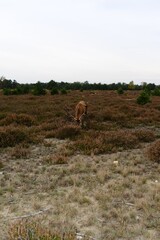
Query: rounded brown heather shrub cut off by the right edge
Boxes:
[{"xmin": 146, "ymin": 140, "xmax": 160, "ymax": 163}]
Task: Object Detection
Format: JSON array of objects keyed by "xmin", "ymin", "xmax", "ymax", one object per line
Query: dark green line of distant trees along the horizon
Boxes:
[{"xmin": 0, "ymin": 77, "xmax": 160, "ymax": 95}]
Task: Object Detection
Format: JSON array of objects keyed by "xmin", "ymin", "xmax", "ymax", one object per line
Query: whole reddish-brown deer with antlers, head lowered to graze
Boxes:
[{"xmin": 65, "ymin": 101, "xmax": 88, "ymax": 128}]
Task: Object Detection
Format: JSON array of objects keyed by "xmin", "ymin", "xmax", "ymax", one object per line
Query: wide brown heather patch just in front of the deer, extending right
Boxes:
[{"xmin": 70, "ymin": 131, "xmax": 139, "ymax": 154}]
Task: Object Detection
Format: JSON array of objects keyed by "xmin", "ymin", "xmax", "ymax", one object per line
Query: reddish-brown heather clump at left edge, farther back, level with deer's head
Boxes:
[{"xmin": 0, "ymin": 114, "xmax": 35, "ymax": 127}]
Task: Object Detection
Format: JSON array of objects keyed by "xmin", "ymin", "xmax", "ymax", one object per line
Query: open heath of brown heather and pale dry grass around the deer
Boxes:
[{"xmin": 0, "ymin": 91, "xmax": 160, "ymax": 240}]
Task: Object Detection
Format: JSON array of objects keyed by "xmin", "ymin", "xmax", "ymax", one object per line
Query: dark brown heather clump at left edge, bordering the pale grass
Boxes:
[{"xmin": 0, "ymin": 128, "xmax": 30, "ymax": 147}]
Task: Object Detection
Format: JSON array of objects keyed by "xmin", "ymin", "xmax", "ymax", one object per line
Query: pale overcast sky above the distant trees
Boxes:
[{"xmin": 0, "ymin": 0, "xmax": 160, "ymax": 85}]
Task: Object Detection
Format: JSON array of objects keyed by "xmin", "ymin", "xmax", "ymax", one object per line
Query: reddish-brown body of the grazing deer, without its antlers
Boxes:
[{"xmin": 74, "ymin": 101, "xmax": 87, "ymax": 127}]
